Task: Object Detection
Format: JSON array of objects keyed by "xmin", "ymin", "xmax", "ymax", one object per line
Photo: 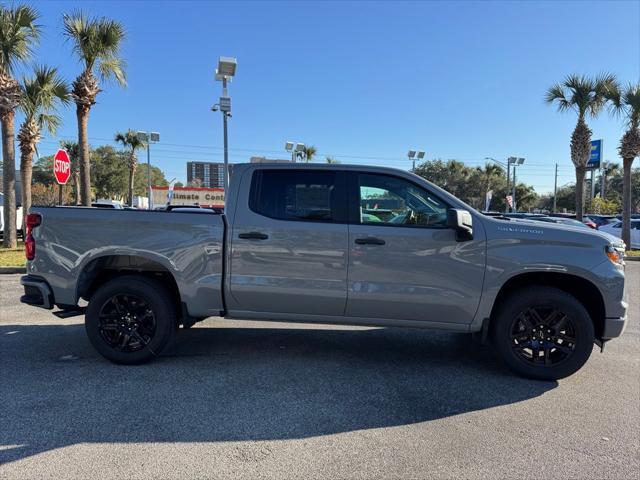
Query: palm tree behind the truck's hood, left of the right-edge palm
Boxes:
[{"xmin": 545, "ymin": 74, "xmax": 614, "ymax": 221}]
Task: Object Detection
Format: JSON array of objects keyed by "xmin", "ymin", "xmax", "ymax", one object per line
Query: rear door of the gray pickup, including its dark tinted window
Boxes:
[{"xmin": 229, "ymin": 168, "xmax": 348, "ymax": 316}]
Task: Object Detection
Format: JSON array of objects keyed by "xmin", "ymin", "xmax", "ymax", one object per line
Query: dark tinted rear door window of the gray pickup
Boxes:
[{"xmin": 249, "ymin": 170, "xmax": 344, "ymax": 222}]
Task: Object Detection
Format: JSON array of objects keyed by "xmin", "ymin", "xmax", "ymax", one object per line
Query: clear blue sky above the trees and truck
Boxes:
[{"xmin": 17, "ymin": 1, "xmax": 640, "ymax": 192}]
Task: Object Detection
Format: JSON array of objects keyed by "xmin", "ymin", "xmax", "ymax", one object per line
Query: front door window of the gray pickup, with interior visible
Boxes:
[{"xmin": 358, "ymin": 174, "xmax": 449, "ymax": 228}]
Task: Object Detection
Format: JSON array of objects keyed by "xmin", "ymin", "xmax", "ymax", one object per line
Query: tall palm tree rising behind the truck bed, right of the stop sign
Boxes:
[{"xmin": 64, "ymin": 11, "xmax": 126, "ymax": 206}]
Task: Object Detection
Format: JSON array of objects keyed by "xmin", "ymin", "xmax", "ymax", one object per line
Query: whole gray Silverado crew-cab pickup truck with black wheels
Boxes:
[{"xmin": 22, "ymin": 164, "xmax": 627, "ymax": 379}]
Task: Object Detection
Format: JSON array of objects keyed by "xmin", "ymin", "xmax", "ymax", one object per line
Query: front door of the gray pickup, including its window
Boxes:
[{"xmin": 346, "ymin": 172, "xmax": 486, "ymax": 324}]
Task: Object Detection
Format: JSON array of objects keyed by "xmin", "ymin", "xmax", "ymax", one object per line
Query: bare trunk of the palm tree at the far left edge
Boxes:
[{"xmin": 2, "ymin": 112, "xmax": 18, "ymax": 248}]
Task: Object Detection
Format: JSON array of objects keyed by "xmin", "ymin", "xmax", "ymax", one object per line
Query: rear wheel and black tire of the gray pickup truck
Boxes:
[{"xmin": 85, "ymin": 275, "xmax": 176, "ymax": 365}]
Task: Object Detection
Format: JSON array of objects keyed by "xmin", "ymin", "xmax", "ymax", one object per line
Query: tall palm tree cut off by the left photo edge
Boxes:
[{"xmin": 0, "ymin": 5, "xmax": 40, "ymax": 248}]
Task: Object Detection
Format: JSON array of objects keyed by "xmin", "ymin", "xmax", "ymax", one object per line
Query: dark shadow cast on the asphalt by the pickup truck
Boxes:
[{"xmin": 0, "ymin": 321, "xmax": 557, "ymax": 464}]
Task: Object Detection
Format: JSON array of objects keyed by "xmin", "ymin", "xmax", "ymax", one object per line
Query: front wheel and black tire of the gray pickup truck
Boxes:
[{"xmin": 491, "ymin": 286, "xmax": 595, "ymax": 380}]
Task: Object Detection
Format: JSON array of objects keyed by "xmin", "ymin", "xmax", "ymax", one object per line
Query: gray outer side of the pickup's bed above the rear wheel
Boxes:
[{"xmin": 27, "ymin": 207, "xmax": 225, "ymax": 317}]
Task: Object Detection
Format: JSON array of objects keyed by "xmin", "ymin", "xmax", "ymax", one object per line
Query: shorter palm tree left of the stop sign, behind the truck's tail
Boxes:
[{"xmin": 18, "ymin": 66, "xmax": 69, "ymax": 222}]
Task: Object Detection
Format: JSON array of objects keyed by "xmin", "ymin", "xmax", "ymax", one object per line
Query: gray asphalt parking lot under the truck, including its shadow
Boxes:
[{"xmin": 0, "ymin": 263, "xmax": 640, "ymax": 479}]
